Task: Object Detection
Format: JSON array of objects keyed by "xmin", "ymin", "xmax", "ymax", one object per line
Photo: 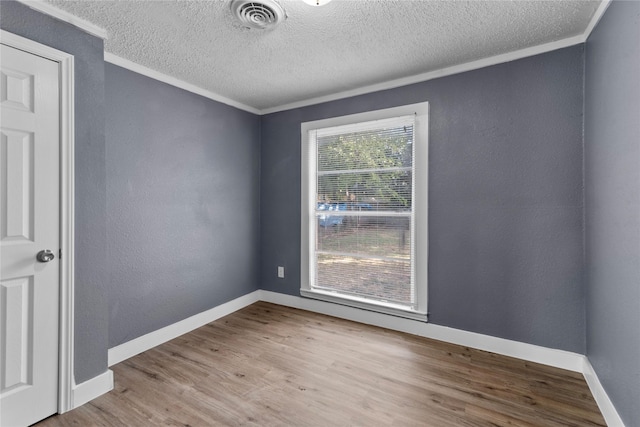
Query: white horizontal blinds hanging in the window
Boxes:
[{"xmin": 308, "ymin": 115, "xmax": 416, "ymax": 310}]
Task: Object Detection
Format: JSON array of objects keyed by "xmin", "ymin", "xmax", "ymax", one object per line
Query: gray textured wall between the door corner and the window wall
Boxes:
[{"xmin": 105, "ymin": 64, "xmax": 260, "ymax": 347}]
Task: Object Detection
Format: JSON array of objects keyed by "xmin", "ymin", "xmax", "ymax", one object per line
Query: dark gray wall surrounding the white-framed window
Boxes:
[{"xmin": 261, "ymin": 46, "xmax": 585, "ymax": 353}]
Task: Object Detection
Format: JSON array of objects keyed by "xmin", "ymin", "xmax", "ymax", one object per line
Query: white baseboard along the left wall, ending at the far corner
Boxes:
[{"xmin": 107, "ymin": 291, "xmax": 260, "ymax": 366}]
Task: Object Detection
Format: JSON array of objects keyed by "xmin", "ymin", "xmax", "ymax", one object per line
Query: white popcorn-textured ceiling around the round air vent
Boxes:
[{"xmin": 47, "ymin": 0, "xmax": 600, "ymax": 110}]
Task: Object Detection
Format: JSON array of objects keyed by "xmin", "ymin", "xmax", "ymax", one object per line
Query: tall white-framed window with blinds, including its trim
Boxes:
[{"xmin": 301, "ymin": 103, "xmax": 428, "ymax": 320}]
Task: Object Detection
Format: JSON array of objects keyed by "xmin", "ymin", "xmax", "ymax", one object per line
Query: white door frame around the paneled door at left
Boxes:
[{"xmin": 0, "ymin": 30, "xmax": 75, "ymax": 413}]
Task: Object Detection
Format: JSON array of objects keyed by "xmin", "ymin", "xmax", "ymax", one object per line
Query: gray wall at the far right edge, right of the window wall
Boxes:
[{"xmin": 585, "ymin": 1, "xmax": 640, "ymax": 427}]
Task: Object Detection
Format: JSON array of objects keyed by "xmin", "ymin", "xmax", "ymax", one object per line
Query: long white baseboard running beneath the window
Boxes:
[{"xmin": 260, "ymin": 291, "xmax": 584, "ymax": 372}]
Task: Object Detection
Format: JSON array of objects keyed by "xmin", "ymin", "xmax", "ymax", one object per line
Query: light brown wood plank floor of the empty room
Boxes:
[{"xmin": 38, "ymin": 302, "xmax": 605, "ymax": 427}]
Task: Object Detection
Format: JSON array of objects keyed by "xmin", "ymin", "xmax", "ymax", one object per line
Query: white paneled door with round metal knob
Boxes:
[{"xmin": 0, "ymin": 45, "xmax": 60, "ymax": 427}]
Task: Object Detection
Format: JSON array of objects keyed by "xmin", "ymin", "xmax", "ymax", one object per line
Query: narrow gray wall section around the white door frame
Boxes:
[{"xmin": 0, "ymin": 0, "xmax": 108, "ymax": 383}]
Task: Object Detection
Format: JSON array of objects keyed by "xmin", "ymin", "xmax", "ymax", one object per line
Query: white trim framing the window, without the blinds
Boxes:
[{"xmin": 300, "ymin": 102, "xmax": 429, "ymax": 321}]
